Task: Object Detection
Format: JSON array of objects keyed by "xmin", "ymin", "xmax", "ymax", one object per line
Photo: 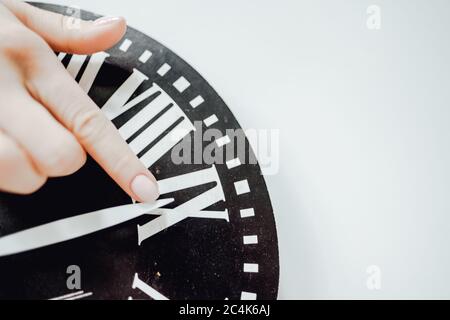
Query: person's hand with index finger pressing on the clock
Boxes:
[{"xmin": 0, "ymin": 0, "xmax": 159, "ymax": 202}]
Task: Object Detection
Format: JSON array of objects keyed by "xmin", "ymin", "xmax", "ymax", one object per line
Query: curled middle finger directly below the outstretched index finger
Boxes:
[{"xmin": 0, "ymin": 85, "xmax": 86, "ymax": 177}]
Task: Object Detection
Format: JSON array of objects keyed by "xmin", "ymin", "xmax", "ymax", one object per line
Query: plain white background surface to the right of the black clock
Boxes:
[{"xmin": 44, "ymin": 0, "xmax": 450, "ymax": 299}]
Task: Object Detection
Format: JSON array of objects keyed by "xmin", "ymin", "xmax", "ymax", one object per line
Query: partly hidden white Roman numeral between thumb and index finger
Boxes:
[{"xmin": 59, "ymin": 52, "xmax": 109, "ymax": 92}]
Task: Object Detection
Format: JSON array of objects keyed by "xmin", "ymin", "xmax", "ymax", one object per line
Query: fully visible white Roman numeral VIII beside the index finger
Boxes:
[{"xmin": 102, "ymin": 69, "xmax": 195, "ymax": 168}]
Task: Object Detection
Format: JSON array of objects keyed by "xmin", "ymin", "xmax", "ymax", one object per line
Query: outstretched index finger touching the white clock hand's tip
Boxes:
[{"xmin": 27, "ymin": 51, "xmax": 159, "ymax": 202}]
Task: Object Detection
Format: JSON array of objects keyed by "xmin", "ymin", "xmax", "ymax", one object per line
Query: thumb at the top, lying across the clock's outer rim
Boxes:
[{"xmin": 1, "ymin": 0, "xmax": 126, "ymax": 54}]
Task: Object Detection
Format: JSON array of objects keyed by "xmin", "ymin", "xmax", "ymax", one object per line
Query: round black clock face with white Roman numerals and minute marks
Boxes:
[{"xmin": 0, "ymin": 4, "xmax": 279, "ymax": 300}]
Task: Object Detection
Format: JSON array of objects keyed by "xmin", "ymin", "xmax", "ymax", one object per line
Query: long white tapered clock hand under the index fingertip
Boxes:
[{"xmin": 0, "ymin": 199, "xmax": 173, "ymax": 257}]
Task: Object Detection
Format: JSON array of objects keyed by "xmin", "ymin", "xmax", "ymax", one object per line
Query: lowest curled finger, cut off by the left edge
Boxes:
[{"xmin": 0, "ymin": 132, "xmax": 46, "ymax": 194}]
